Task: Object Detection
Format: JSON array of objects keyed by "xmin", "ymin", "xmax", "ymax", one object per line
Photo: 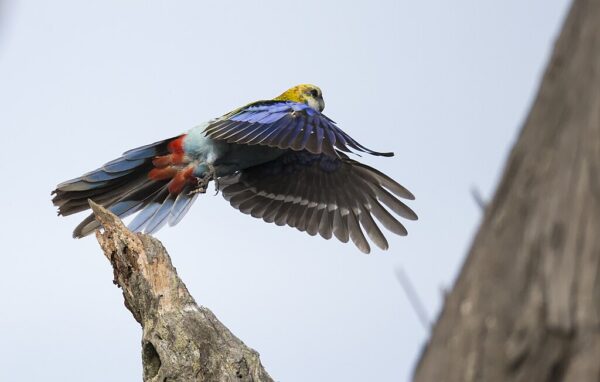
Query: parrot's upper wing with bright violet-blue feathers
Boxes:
[{"xmin": 205, "ymin": 101, "xmax": 394, "ymax": 156}]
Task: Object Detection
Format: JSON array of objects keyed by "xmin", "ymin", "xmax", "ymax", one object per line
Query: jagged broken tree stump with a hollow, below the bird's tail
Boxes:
[{"xmin": 90, "ymin": 201, "xmax": 272, "ymax": 382}]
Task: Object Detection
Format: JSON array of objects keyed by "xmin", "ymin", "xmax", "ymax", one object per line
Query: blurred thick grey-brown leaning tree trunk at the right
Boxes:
[{"xmin": 414, "ymin": 0, "xmax": 600, "ymax": 382}]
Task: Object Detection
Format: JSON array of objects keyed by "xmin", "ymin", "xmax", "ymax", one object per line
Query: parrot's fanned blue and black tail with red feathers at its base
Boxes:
[{"xmin": 52, "ymin": 135, "xmax": 198, "ymax": 238}]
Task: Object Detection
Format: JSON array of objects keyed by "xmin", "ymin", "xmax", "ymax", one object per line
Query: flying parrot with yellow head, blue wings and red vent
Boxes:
[{"xmin": 52, "ymin": 84, "xmax": 418, "ymax": 253}]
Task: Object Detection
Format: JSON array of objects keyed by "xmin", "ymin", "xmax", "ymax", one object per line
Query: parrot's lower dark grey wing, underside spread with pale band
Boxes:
[{"xmin": 222, "ymin": 151, "xmax": 417, "ymax": 253}]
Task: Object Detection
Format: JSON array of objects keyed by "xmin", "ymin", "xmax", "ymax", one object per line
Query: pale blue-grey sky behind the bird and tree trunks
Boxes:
[{"xmin": 0, "ymin": 0, "xmax": 569, "ymax": 382}]
